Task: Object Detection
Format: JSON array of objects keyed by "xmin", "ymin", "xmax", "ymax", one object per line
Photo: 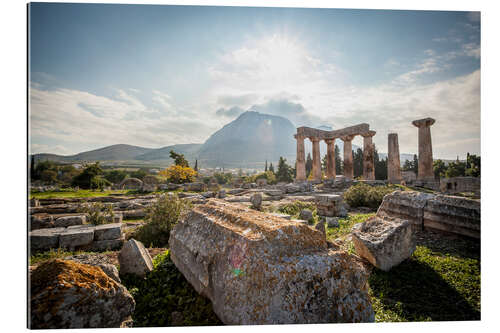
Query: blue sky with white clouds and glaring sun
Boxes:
[{"xmin": 30, "ymin": 3, "xmax": 481, "ymax": 158}]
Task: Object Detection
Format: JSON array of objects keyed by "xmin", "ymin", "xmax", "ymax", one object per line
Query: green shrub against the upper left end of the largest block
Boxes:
[{"xmin": 133, "ymin": 193, "xmax": 191, "ymax": 247}]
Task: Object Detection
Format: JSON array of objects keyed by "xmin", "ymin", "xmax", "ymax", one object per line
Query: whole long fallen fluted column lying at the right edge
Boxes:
[{"xmin": 377, "ymin": 191, "xmax": 481, "ymax": 239}]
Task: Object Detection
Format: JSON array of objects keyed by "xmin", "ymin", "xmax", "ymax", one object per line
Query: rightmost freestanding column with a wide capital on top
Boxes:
[{"xmin": 412, "ymin": 118, "xmax": 436, "ymax": 180}]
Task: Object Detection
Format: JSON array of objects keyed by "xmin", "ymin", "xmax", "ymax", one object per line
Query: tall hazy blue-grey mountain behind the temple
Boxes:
[{"xmin": 198, "ymin": 111, "xmax": 297, "ymax": 167}]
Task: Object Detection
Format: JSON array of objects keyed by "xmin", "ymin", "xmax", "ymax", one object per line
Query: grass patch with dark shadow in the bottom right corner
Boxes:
[{"xmin": 369, "ymin": 246, "xmax": 481, "ymax": 322}]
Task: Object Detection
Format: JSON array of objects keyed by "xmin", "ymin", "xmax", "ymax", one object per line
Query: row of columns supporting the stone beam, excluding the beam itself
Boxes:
[{"xmin": 294, "ymin": 131, "xmax": 376, "ymax": 181}]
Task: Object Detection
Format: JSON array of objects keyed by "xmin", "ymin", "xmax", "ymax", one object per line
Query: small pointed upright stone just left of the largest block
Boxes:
[{"xmin": 118, "ymin": 238, "xmax": 153, "ymax": 276}]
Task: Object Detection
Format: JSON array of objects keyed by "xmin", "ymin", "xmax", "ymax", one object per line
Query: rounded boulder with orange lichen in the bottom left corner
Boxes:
[{"xmin": 29, "ymin": 259, "xmax": 135, "ymax": 329}]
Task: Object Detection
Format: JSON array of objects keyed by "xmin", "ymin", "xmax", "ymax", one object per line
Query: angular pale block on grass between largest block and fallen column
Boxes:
[{"xmin": 352, "ymin": 216, "xmax": 416, "ymax": 271}]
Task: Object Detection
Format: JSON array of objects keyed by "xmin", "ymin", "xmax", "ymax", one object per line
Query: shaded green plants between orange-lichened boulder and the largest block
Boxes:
[{"xmin": 121, "ymin": 251, "xmax": 222, "ymax": 327}]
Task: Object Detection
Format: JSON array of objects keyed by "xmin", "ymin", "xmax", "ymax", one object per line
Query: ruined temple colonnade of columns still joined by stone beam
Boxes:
[{"xmin": 294, "ymin": 124, "xmax": 376, "ymax": 181}]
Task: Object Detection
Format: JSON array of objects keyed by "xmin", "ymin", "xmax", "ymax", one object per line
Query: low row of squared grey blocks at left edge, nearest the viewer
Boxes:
[{"xmin": 29, "ymin": 223, "xmax": 123, "ymax": 252}]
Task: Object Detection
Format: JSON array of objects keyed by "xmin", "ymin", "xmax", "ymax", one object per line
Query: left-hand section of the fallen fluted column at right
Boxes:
[{"xmin": 377, "ymin": 191, "xmax": 434, "ymax": 230}]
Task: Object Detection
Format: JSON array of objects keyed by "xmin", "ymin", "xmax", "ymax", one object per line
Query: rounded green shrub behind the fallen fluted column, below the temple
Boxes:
[{"xmin": 344, "ymin": 183, "xmax": 394, "ymax": 208}]
